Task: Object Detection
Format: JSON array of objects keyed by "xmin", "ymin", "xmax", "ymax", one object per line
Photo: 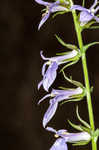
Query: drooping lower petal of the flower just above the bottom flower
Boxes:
[{"xmin": 43, "ymin": 99, "xmax": 58, "ymax": 128}]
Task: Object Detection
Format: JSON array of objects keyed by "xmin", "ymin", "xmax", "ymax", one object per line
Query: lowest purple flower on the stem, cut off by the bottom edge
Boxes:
[{"xmin": 46, "ymin": 127, "xmax": 91, "ymax": 150}]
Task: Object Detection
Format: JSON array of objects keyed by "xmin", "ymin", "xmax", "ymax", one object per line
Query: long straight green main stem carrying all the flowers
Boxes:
[{"xmin": 71, "ymin": 2, "xmax": 97, "ymax": 150}]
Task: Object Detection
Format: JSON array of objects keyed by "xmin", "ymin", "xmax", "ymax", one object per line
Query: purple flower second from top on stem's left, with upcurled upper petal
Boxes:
[{"xmin": 38, "ymin": 50, "xmax": 78, "ymax": 91}]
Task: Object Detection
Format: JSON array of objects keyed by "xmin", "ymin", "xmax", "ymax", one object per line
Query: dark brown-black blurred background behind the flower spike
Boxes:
[{"xmin": 0, "ymin": 0, "xmax": 99, "ymax": 150}]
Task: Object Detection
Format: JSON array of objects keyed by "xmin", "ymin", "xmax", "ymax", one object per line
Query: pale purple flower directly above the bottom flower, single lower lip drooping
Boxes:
[{"xmin": 38, "ymin": 87, "xmax": 83, "ymax": 128}]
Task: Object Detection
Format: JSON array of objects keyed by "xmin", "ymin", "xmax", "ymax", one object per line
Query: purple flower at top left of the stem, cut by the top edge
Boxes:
[{"xmin": 35, "ymin": 0, "xmax": 69, "ymax": 29}]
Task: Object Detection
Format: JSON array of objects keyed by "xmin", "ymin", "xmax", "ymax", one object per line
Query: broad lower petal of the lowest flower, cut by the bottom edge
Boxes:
[{"xmin": 50, "ymin": 138, "xmax": 68, "ymax": 150}]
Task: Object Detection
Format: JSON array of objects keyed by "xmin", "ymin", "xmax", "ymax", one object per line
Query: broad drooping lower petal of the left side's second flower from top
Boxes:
[{"xmin": 43, "ymin": 62, "xmax": 58, "ymax": 91}]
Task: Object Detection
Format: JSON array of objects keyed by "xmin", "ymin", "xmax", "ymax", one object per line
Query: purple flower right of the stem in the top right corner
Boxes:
[{"xmin": 71, "ymin": 0, "xmax": 99, "ymax": 25}]
